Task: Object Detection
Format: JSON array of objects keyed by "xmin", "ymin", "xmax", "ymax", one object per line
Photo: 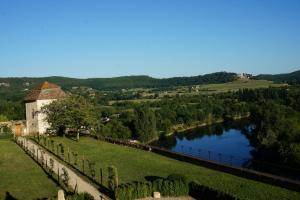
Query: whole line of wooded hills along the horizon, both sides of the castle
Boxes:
[{"xmin": 0, "ymin": 70, "xmax": 300, "ymax": 91}]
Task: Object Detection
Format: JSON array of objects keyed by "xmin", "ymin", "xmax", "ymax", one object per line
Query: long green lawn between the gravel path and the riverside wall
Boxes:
[{"xmin": 53, "ymin": 137, "xmax": 300, "ymax": 200}]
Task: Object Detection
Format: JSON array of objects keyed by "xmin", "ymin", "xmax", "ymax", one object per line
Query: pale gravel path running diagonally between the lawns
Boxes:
[{"xmin": 17, "ymin": 137, "xmax": 110, "ymax": 200}]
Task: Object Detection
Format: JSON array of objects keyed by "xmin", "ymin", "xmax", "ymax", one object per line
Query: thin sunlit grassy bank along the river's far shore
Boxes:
[{"xmin": 145, "ymin": 112, "xmax": 250, "ymax": 144}]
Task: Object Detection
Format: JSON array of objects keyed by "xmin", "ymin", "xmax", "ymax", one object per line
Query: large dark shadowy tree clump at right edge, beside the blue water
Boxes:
[{"xmin": 250, "ymin": 101, "xmax": 300, "ymax": 167}]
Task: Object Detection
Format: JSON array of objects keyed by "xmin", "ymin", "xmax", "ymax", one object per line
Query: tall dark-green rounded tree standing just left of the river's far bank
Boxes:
[{"xmin": 134, "ymin": 106, "xmax": 157, "ymax": 142}]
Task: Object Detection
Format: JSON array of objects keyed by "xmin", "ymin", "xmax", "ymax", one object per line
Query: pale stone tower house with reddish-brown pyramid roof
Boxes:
[{"xmin": 25, "ymin": 81, "xmax": 66, "ymax": 135}]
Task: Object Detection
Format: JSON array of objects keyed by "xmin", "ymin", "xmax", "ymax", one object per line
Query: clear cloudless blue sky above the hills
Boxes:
[{"xmin": 0, "ymin": 0, "xmax": 300, "ymax": 77}]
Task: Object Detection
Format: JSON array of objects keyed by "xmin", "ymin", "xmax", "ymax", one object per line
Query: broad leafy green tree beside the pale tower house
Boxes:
[{"xmin": 42, "ymin": 95, "xmax": 99, "ymax": 140}]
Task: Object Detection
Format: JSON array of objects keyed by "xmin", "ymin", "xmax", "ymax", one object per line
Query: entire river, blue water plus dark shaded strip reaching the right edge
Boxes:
[{"xmin": 151, "ymin": 119, "xmax": 300, "ymax": 180}]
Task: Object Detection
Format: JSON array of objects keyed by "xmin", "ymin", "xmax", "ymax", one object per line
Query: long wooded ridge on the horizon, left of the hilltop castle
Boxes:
[{"xmin": 0, "ymin": 72, "xmax": 237, "ymax": 92}]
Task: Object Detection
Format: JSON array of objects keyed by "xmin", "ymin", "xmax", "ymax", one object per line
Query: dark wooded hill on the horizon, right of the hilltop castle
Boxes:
[{"xmin": 252, "ymin": 70, "xmax": 300, "ymax": 84}]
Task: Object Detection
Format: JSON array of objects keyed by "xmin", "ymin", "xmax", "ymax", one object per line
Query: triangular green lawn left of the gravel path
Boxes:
[{"xmin": 0, "ymin": 139, "xmax": 59, "ymax": 200}]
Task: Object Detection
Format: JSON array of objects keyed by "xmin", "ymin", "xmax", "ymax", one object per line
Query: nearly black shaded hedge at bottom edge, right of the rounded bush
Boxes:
[{"xmin": 189, "ymin": 182, "xmax": 238, "ymax": 200}]
